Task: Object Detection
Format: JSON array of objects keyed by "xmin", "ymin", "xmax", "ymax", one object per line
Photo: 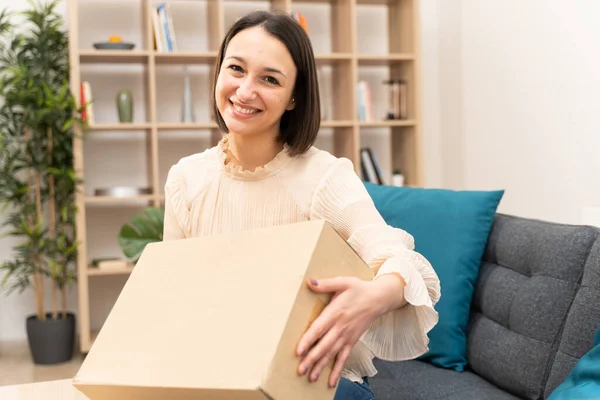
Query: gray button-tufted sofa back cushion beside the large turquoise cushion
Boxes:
[{"xmin": 468, "ymin": 215, "xmax": 600, "ymax": 399}]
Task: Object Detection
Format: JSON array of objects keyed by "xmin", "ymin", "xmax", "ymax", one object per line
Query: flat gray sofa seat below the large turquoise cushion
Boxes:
[{"xmin": 369, "ymin": 360, "xmax": 518, "ymax": 400}]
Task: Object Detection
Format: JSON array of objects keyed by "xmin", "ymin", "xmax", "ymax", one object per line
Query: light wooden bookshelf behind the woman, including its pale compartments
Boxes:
[{"xmin": 67, "ymin": 0, "xmax": 423, "ymax": 353}]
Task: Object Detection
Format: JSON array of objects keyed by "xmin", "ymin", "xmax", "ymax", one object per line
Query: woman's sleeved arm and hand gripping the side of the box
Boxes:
[{"xmin": 298, "ymin": 159, "xmax": 440, "ymax": 383}]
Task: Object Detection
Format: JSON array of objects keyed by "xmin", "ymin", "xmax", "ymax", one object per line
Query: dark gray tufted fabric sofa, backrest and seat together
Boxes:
[{"xmin": 370, "ymin": 214, "xmax": 600, "ymax": 400}]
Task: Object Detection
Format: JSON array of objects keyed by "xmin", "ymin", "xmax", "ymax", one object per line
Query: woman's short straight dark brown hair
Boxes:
[{"xmin": 211, "ymin": 10, "xmax": 321, "ymax": 156}]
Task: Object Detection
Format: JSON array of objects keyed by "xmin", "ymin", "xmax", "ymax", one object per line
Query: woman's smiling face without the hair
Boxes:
[{"xmin": 215, "ymin": 26, "xmax": 296, "ymax": 141}]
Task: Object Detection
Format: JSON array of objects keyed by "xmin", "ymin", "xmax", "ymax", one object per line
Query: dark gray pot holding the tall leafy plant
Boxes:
[{"xmin": 27, "ymin": 313, "xmax": 75, "ymax": 365}]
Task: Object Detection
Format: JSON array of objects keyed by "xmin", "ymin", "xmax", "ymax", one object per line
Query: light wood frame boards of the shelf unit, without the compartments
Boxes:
[{"xmin": 68, "ymin": 0, "xmax": 423, "ymax": 353}]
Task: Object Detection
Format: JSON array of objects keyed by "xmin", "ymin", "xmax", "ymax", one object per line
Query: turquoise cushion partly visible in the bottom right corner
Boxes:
[{"xmin": 546, "ymin": 328, "xmax": 600, "ymax": 400}]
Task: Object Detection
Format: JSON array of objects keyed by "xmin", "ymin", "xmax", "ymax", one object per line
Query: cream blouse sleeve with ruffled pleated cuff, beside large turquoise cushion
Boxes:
[{"xmin": 311, "ymin": 158, "xmax": 440, "ymax": 361}]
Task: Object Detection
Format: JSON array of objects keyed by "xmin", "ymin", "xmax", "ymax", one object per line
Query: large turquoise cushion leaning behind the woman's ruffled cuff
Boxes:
[{"xmin": 364, "ymin": 182, "xmax": 504, "ymax": 372}]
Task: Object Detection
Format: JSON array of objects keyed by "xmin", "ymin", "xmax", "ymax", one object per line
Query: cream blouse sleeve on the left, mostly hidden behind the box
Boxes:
[{"xmin": 163, "ymin": 165, "xmax": 188, "ymax": 241}]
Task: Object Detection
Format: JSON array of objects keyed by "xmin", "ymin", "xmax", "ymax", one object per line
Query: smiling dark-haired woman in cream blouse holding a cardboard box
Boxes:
[{"xmin": 164, "ymin": 11, "xmax": 440, "ymax": 400}]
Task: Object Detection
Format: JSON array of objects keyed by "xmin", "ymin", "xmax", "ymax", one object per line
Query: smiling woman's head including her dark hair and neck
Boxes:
[{"xmin": 212, "ymin": 11, "xmax": 321, "ymax": 168}]
